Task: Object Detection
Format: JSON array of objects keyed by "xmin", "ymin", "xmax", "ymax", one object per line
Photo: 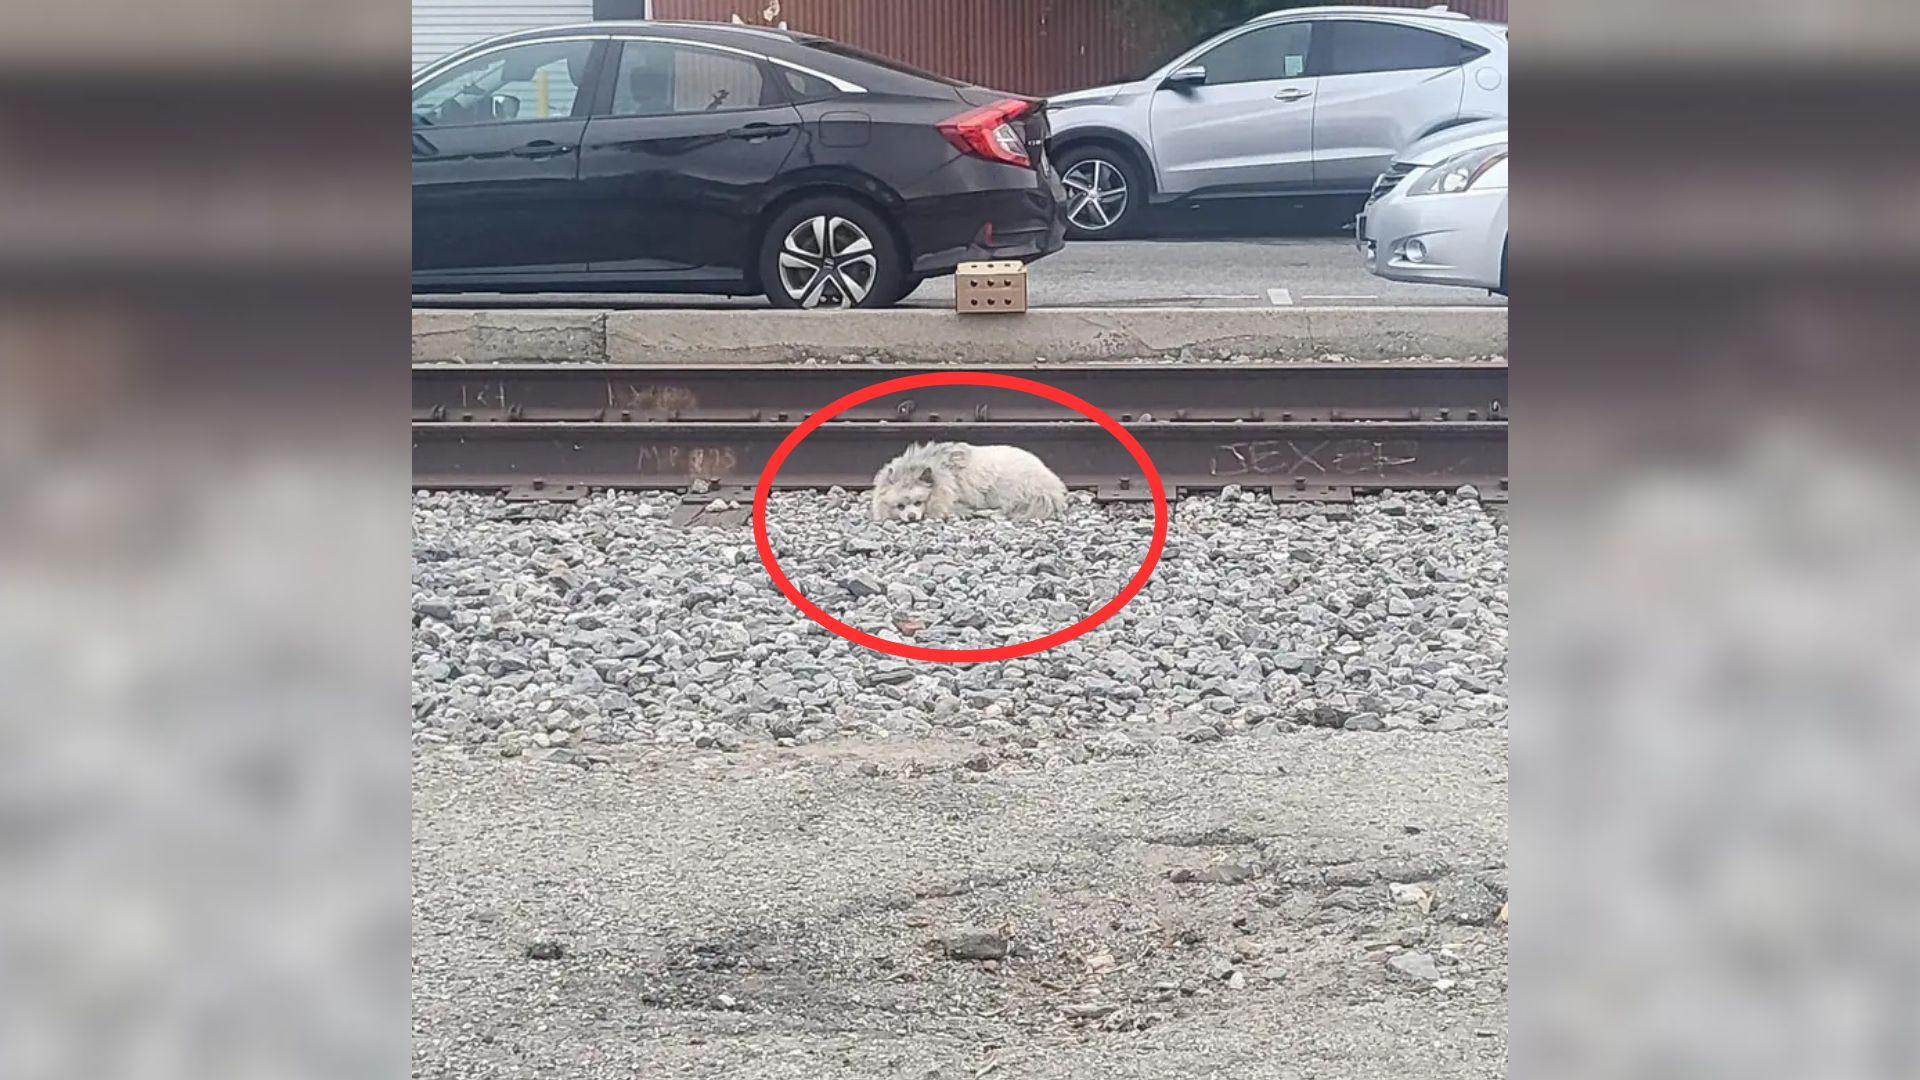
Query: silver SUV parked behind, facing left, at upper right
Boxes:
[{"xmin": 1046, "ymin": 8, "xmax": 1507, "ymax": 238}]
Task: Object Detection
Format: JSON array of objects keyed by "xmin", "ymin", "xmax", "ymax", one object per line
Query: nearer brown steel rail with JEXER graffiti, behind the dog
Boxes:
[{"xmin": 413, "ymin": 417, "xmax": 1507, "ymax": 498}]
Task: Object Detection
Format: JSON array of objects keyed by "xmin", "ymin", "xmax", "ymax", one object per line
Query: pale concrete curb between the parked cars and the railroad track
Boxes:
[{"xmin": 413, "ymin": 306, "xmax": 1507, "ymax": 363}]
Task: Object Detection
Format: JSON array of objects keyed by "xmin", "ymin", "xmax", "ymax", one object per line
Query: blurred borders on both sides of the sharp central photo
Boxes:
[{"xmin": 0, "ymin": 0, "xmax": 1920, "ymax": 1080}]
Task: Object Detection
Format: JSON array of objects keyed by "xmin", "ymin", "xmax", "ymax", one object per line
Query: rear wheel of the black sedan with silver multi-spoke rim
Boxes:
[{"xmin": 760, "ymin": 196, "xmax": 906, "ymax": 307}]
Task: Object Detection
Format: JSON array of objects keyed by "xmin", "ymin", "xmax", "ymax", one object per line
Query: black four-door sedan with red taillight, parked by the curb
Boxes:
[{"xmin": 413, "ymin": 23, "xmax": 1066, "ymax": 307}]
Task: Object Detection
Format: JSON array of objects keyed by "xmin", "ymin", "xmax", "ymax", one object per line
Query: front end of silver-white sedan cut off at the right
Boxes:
[{"xmin": 1354, "ymin": 121, "xmax": 1507, "ymax": 296}]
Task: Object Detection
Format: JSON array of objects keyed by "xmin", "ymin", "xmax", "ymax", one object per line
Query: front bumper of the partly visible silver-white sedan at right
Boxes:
[{"xmin": 1354, "ymin": 175, "xmax": 1507, "ymax": 290}]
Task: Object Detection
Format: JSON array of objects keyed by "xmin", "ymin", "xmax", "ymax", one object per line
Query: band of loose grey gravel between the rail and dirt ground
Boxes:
[{"xmin": 413, "ymin": 490, "xmax": 1507, "ymax": 757}]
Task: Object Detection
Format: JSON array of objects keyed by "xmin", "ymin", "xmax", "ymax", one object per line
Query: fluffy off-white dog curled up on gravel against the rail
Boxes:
[{"xmin": 874, "ymin": 442, "xmax": 1068, "ymax": 521}]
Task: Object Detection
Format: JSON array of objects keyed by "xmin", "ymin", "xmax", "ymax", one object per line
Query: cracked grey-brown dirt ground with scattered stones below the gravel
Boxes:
[{"xmin": 413, "ymin": 730, "xmax": 1507, "ymax": 1080}]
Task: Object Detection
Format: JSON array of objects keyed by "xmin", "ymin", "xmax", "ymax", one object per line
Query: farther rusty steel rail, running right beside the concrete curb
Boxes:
[{"xmin": 413, "ymin": 363, "xmax": 1507, "ymax": 423}]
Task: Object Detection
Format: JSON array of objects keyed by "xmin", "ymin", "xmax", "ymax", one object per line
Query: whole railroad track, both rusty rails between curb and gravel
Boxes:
[{"xmin": 413, "ymin": 363, "xmax": 1507, "ymax": 500}]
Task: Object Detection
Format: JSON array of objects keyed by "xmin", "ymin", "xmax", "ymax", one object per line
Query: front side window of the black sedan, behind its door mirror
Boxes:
[{"xmin": 413, "ymin": 40, "xmax": 593, "ymax": 127}]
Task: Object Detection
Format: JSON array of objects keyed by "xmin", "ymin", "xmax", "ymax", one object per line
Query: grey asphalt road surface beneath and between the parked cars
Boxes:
[{"xmin": 417, "ymin": 236, "xmax": 1505, "ymax": 307}]
